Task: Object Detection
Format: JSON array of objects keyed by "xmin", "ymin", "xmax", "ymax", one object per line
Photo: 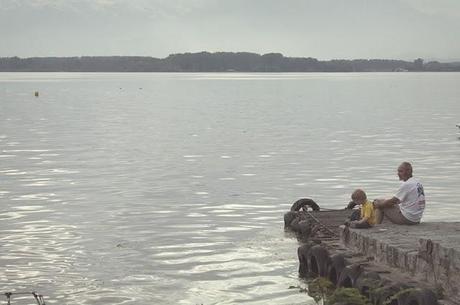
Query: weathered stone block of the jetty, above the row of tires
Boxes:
[{"xmin": 340, "ymin": 222, "xmax": 460, "ymax": 304}]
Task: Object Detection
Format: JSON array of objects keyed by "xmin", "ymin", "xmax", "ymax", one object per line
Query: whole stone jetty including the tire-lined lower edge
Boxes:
[{"xmin": 284, "ymin": 202, "xmax": 460, "ymax": 305}]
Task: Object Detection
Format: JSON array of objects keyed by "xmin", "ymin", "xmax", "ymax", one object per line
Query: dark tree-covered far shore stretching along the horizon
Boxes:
[{"xmin": 0, "ymin": 52, "xmax": 460, "ymax": 72}]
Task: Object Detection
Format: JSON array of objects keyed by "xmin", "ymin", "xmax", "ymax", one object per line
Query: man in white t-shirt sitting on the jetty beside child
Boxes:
[{"xmin": 374, "ymin": 162, "xmax": 425, "ymax": 225}]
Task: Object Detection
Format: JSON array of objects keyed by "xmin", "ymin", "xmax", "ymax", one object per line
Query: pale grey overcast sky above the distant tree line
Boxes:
[{"xmin": 0, "ymin": 0, "xmax": 460, "ymax": 60}]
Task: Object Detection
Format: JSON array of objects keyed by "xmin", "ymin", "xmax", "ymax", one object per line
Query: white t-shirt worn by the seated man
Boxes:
[{"xmin": 395, "ymin": 177, "xmax": 425, "ymax": 222}]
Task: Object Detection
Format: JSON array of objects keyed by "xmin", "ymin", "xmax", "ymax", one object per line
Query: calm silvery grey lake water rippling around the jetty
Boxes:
[{"xmin": 0, "ymin": 73, "xmax": 460, "ymax": 305}]
